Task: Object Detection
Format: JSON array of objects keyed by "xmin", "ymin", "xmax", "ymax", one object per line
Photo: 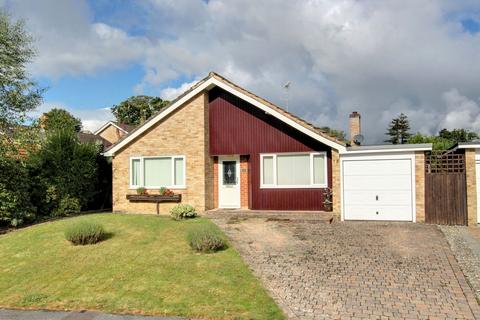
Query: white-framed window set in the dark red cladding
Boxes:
[{"xmin": 260, "ymin": 152, "xmax": 327, "ymax": 188}]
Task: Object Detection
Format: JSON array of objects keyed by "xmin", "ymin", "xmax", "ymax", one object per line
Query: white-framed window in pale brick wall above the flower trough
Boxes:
[{"xmin": 130, "ymin": 156, "xmax": 185, "ymax": 189}]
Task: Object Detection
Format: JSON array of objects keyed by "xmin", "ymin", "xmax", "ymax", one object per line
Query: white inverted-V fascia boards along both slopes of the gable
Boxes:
[{"xmin": 104, "ymin": 77, "xmax": 347, "ymax": 157}]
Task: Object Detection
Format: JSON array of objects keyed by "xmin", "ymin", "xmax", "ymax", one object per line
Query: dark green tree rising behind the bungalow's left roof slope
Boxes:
[{"xmin": 111, "ymin": 96, "xmax": 169, "ymax": 125}]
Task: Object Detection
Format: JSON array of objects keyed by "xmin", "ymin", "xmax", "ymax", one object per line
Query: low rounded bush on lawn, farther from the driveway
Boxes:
[{"xmin": 65, "ymin": 221, "xmax": 106, "ymax": 245}]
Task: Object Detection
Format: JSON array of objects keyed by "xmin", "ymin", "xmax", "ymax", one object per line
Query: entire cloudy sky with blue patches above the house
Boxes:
[{"xmin": 0, "ymin": 0, "xmax": 480, "ymax": 144}]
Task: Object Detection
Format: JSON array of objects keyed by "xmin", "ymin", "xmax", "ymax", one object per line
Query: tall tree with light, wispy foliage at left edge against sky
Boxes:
[{"xmin": 0, "ymin": 12, "xmax": 44, "ymax": 132}]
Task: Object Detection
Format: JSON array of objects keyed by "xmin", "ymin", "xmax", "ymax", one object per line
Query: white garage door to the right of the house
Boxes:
[{"xmin": 343, "ymin": 159, "xmax": 413, "ymax": 221}]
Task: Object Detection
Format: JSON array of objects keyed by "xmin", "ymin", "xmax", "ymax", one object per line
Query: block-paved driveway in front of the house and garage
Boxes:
[{"xmin": 212, "ymin": 212, "xmax": 480, "ymax": 319}]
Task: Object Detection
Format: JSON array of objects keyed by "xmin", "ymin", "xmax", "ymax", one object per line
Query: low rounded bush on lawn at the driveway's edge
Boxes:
[{"xmin": 187, "ymin": 225, "xmax": 228, "ymax": 253}]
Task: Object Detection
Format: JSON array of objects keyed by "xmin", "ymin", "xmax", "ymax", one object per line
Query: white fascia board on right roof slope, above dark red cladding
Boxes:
[{"xmin": 211, "ymin": 78, "xmax": 347, "ymax": 153}]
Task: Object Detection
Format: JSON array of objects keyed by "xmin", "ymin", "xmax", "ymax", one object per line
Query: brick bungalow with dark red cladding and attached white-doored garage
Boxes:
[{"xmin": 104, "ymin": 73, "xmax": 431, "ymax": 221}]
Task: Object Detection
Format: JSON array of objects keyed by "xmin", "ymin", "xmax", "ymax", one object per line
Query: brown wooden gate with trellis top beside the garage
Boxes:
[{"xmin": 425, "ymin": 151, "xmax": 467, "ymax": 225}]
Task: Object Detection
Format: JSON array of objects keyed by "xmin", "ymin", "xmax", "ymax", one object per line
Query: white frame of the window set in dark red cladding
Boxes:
[{"xmin": 260, "ymin": 151, "xmax": 328, "ymax": 189}]
